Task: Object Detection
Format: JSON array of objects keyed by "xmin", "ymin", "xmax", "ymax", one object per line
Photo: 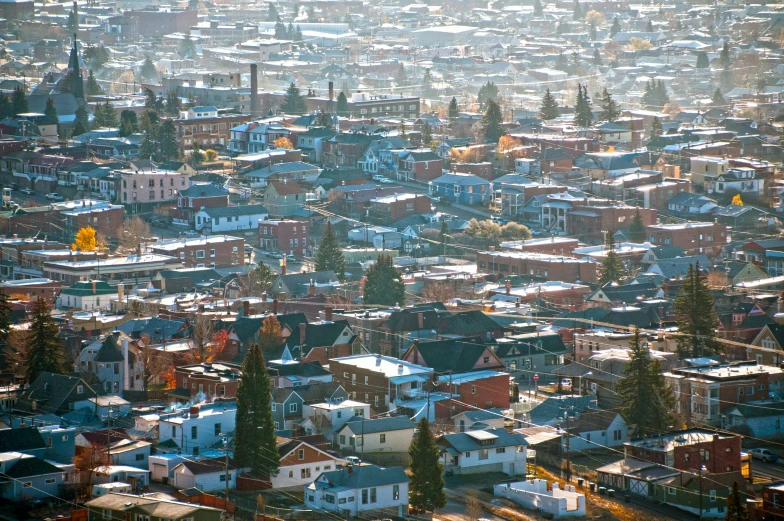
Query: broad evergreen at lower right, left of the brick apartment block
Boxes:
[{"xmin": 617, "ymin": 329, "xmax": 675, "ymax": 436}]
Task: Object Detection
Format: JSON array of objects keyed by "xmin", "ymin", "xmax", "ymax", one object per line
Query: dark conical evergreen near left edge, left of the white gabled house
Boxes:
[{"xmin": 24, "ymin": 297, "xmax": 64, "ymax": 383}]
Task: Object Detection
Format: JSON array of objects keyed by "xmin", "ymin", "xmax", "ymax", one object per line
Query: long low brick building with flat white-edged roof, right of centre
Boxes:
[{"xmin": 476, "ymin": 251, "xmax": 597, "ymax": 283}]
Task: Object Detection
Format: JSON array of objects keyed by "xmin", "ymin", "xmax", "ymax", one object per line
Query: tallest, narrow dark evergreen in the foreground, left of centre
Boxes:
[{"xmin": 234, "ymin": 344, "xmax": 280, "ymax": 477}]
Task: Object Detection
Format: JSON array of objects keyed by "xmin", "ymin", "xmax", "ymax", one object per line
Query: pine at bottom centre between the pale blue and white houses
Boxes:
[{"xmin": 408, "ymin": 418, "xmax": 446, "ymax": 512}]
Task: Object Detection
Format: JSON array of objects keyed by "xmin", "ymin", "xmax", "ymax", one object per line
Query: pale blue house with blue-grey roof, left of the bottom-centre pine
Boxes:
[{"xmin": 305, "ymin": 465, "xmax": 411, "ymax": 516}]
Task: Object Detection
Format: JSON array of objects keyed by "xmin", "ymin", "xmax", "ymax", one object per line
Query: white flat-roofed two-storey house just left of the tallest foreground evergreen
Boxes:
[{"xmin": 158, "ymin": 404, "xmax": 237, "ymax": 456}]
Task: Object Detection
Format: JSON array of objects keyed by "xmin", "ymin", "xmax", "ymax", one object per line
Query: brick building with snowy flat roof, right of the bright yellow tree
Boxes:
[{"xmin": 148, "ymin": 235, "xmax": 245, "ymax": 268}]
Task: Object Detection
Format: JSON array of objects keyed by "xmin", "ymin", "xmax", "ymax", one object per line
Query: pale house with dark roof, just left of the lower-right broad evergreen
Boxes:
[{"xmin": 561, "ymin": 408, "xmax": 629, "ymax": 452}]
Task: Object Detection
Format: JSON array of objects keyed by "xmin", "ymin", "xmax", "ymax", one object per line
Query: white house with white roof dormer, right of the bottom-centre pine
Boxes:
[{"xmin": 436, "ymin": 428, "xmax": 528, "ymax": 476}]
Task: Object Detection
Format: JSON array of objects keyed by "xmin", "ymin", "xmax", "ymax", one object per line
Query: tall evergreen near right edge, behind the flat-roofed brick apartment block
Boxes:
[{"xmin": 673, "ymin": 263, "xmax": 720, "ymax": 359}]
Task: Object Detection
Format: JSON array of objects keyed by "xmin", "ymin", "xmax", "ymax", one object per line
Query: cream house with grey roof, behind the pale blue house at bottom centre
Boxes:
[{"xmin": 337, "ymin": 416, "xmax": 416, "ymax": 454}]
